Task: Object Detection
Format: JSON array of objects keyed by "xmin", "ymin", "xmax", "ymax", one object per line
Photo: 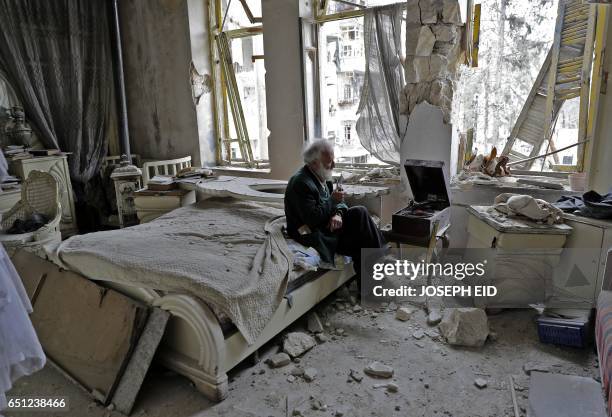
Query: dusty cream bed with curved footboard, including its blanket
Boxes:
[{"xmin": 33, "ymin": 198, "xmax": 354, "ymax": 401}]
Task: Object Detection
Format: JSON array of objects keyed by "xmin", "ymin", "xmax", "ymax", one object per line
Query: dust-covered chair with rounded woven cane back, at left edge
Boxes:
[{"xmin": 0, "ymin": 171, "xmax": 62, "ymax": 257}]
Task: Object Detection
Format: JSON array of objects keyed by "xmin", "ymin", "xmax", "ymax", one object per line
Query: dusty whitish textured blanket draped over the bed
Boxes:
[{"xmin": 54, "ymin": 199, "xmax": 293, "ymax": 344}]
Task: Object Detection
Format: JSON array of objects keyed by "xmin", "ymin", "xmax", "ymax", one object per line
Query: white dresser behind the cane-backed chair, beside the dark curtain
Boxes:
[{"xmin": 9, "ymin": 155, "xmax": 78, "ymax": 237}]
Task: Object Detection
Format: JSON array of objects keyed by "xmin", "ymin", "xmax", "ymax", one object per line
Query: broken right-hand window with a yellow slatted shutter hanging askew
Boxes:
[{"xmin": 453, "ymin": 0, "xmax": 605, "ymax": 172}]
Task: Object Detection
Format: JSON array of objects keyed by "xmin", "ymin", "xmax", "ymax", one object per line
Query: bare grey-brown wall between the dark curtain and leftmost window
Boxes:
[{"xmin": 119, "ymin": 0, "xmax": 214, "ymax": 165}]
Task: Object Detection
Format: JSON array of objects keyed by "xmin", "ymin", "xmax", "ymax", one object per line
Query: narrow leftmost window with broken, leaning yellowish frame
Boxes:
[{"xmin": 211, "ymin": 0, "xmax": 269, "ymax": 168}]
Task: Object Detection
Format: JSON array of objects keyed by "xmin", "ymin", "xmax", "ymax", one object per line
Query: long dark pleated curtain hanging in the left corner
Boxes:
[{"xmin": 0, "ymin": 0, "xmax": 113, "ymax": 192}]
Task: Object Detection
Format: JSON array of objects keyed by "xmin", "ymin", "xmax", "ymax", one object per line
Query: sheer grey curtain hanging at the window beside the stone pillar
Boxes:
[{"xmin": 356, "ymin": 3, "xmax": 406, "ymax": 165}]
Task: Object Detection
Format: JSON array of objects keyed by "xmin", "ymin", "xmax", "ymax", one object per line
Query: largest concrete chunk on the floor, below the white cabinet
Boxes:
[{"xmin": 439, "ymin": 308, "xmax": 489, "ymax": 347}]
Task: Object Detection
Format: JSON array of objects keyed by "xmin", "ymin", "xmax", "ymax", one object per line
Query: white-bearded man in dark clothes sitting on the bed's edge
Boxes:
[{"xmin": 285, "ymin": 139, "xmax": 385, "ymax": 276}]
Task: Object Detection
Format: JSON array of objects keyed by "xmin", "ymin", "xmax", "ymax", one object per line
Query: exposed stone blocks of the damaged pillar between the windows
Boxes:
[{"xmin": 400, "ymin": 0, "xmax": 463, "ymax": 123}]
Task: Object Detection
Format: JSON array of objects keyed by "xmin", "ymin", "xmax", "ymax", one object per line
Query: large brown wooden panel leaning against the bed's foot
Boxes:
[{"xmin": 31, "ymin": 263, "xmax": 147, "ymax": 403}]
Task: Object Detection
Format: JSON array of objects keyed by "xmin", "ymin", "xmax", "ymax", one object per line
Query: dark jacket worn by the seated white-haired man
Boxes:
[{"xmin": 285, "ymin": 166, "xmax": 347, "ymax": 263}]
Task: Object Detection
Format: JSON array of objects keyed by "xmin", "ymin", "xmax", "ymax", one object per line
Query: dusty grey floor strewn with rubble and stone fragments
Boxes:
[{"xmin": 6, "ymin": 290, "xmax": 599, "ymax": 417}]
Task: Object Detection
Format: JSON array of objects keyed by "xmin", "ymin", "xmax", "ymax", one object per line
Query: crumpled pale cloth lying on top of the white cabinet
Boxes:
[{"xmin": 493, "ymin": 193, "xmax": 563, "ymax": 224}]
